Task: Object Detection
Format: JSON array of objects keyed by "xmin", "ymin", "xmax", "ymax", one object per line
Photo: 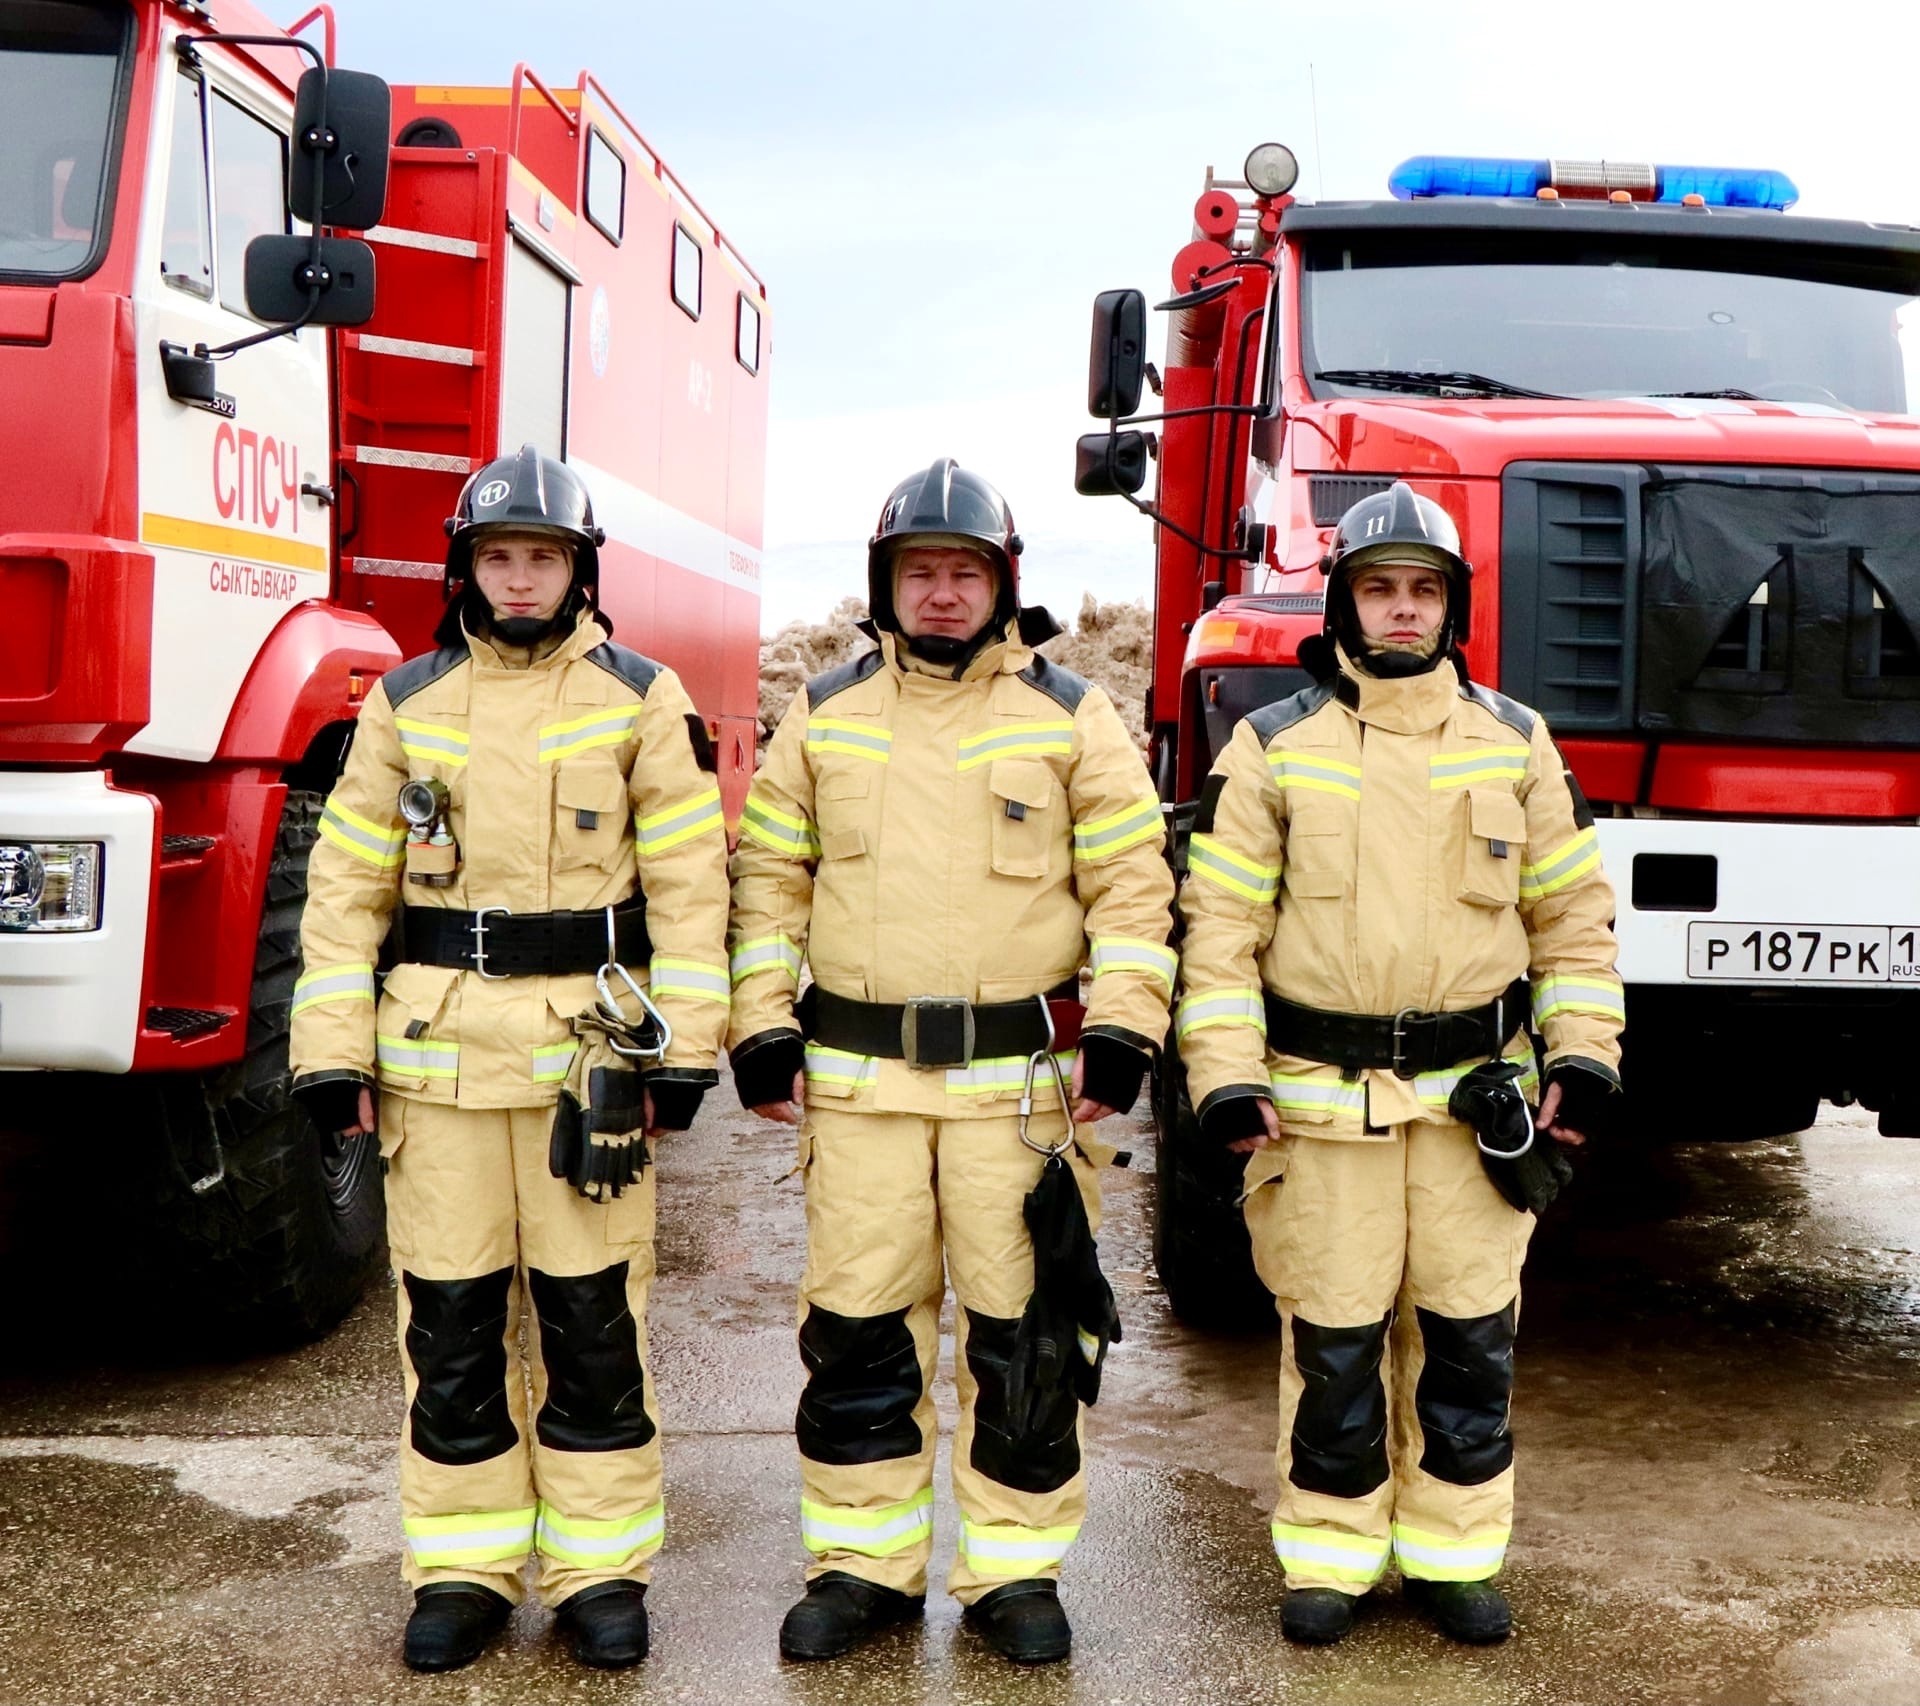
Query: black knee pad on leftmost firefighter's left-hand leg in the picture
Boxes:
[{"xmin": 401, "ymin": 1268, "xmax": 520, "ymax": 1468}]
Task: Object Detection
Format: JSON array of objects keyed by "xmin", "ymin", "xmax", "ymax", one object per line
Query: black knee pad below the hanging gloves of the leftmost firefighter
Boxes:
[{"xmin": 526, "ymin": 1261, "xmax": 655, "ymax": 1451}]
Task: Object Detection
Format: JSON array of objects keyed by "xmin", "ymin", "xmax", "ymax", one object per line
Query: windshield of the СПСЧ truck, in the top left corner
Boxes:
[{"xmin": 0, "ymin": 0, "xmax": 132, "ymax": 282}]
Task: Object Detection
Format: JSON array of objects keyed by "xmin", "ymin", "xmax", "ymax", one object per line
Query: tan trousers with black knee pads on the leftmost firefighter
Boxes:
[{"xmin": 380, "ymin": 1094, "xmax": 662, "ymax": 1606}]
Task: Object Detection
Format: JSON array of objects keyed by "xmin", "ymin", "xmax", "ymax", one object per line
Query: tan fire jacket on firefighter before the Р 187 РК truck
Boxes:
[{"xmin": 1177, "ymin": 656, "xmax": 1626, "ymax": 1136}]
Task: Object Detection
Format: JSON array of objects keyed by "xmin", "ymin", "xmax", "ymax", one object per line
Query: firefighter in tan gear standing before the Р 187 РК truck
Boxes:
[{"xmin": 1175, "ymin": 484, "xmax": 1624, "ymax": 1643}]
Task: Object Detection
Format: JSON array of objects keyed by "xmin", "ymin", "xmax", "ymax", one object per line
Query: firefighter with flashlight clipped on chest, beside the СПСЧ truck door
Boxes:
[{"xmin": 292, "ymin": 447, "xmax": 728, "ymax": 1670}]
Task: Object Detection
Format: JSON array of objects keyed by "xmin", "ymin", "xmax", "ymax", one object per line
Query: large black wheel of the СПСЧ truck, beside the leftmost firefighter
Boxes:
[{"xmin": 144, "ymin": 791, "xmax": 384, "ymax": 1351}]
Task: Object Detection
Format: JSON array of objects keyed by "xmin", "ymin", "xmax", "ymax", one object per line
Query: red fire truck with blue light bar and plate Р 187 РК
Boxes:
[{"xmin": 1077, "ymin": 144, "xmax": 1920, "ymax": 1318}]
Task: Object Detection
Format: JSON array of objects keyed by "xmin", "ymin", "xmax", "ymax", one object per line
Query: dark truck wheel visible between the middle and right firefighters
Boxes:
[{"xmin": 1154, "ymin": 1046, "xmax": 1277, "ymax": 1332}]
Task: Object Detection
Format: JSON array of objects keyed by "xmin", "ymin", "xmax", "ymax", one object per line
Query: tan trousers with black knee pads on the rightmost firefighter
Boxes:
[{"xmin": 1246, "ymin": 1121, "xmax": 1544, "ymax": 1595}]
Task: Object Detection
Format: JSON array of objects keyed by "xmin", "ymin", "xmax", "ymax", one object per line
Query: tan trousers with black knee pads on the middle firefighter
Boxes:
[{"xmin": 795, "ymin": 1103, "xmax": 1104, "ymax": 1602}]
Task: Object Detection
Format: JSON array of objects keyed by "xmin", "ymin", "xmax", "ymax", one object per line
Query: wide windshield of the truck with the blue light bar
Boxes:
[{"xmin": 1302, "ymin": 234, "xmax": 1920, "ymax": 415}]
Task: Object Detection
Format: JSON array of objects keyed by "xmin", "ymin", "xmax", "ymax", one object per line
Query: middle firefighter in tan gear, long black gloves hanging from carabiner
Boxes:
[{"xmin": 730, "ymin": 461, "xmax": 1175, "ymax": 1664}]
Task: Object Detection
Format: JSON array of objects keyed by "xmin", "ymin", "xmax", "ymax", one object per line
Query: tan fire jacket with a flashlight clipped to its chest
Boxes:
[{"xmin": 292, "ymin": 612, "xmax": 728, "ymax": 1107}]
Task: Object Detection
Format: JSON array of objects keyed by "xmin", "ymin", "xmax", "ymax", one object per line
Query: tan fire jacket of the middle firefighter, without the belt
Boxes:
[{"xmin": 728, "ymin": 635, "xmax": 1175, "ymax": 1117}]
